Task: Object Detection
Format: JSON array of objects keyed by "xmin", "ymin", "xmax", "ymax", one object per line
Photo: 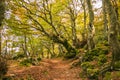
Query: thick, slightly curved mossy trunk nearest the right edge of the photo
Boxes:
[{"xmin": 105, "ymin": 0, "xmax": 120, "ymax": 66}]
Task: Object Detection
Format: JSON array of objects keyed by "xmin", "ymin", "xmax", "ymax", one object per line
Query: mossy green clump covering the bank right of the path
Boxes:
[{"xmin": 81, "ymin": 45, "xmax": 109, "ymax": 80}]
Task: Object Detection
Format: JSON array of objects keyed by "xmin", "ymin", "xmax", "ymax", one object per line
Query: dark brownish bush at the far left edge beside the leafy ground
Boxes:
[{"xmin": 0, "ymin": 58, "xmax": 8, "ymax": 78}]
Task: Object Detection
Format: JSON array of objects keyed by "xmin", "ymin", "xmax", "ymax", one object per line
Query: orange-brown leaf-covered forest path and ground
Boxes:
[{"xmin": 7, "ymin": 58, "xmax": 82, "ymax": 80}]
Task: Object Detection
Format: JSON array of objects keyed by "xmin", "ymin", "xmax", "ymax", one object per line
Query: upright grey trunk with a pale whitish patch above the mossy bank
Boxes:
[{"xmin": 86, "ymin": 0, "xmax": 95, "ymax": 50}]
